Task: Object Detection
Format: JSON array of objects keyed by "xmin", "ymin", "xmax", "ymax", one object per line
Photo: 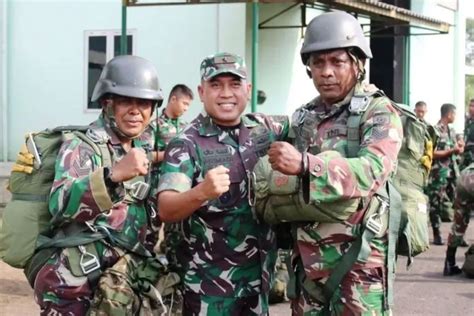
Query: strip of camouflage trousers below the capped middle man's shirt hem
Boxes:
[{"xmin": 183, "ymin": 291, "xmax": 268, "ymax": 316}]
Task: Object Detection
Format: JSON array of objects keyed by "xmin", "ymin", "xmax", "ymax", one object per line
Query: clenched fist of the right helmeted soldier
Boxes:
[{"xmin": 268, "ymin": 142, "xmax": 302, "ymax": 175}]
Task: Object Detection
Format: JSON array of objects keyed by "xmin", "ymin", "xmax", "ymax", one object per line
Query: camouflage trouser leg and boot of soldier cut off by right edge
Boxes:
[{"xmin": 443, "ymin": 163, "xmax": 474, "ymax": 276}]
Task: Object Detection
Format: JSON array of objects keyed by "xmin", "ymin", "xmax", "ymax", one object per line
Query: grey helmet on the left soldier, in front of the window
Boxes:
[{"xmin": 91, "ymin": 55, "xmax": 163, "ymax": 106}]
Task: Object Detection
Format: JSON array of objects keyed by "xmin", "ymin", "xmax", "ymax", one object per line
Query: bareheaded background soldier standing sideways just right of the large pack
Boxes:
[{"xmin": 426, "ymin": 103, "xmax": 464, "ymax": 245}]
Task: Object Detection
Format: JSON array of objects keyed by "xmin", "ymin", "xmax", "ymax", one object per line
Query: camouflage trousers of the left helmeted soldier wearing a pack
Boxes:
[{"xmin": 34, "ymin": 244, "xmax": 120, "ymax": 315}]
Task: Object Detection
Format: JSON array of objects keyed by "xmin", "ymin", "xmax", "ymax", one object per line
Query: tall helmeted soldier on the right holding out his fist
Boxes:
[{"xmin": 268, "ymin": 12, "xmax": 403, "ymax": 315}]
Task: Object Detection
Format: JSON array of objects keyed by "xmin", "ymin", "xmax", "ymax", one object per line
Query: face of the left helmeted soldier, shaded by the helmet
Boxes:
[{"xmin": 113, "ymin": 96, "xmax": 153, "ymax": 137}]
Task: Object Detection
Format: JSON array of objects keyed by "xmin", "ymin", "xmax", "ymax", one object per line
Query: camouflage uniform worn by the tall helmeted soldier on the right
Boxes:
[{"xmin": 292, "ymin": 85, "xmax": 403, "ymax": 315}]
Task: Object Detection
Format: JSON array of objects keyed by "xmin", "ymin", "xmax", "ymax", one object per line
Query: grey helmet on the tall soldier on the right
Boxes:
[{"xmin": 300, "ymin": 11, "xmax": 372, "ymax": 65}]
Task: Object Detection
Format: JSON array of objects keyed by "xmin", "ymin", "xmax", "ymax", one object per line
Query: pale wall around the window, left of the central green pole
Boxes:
[{"xmin": 0, "ymin": 0, "xmax": 246, "ymax": 160}]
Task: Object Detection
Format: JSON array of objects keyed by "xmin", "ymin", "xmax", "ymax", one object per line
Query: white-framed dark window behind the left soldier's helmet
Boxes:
[{"xmin": 84, "ymin": 30, "xmax": 136, "ymax": 111}]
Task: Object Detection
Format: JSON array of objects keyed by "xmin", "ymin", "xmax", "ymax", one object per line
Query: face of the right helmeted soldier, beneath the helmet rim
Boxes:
[{"xmin": 309, "ymin": 49, "xmax": 359, "ymax": 104}]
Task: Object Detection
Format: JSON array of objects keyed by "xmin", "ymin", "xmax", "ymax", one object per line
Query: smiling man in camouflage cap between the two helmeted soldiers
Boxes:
[{"xmin": 158, "ymin": 53, "xmax": 288, "ymax": 316}]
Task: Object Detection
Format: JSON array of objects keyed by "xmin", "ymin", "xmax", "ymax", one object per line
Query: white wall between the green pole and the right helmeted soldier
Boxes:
[{"xmin": 246, "ymin": 3, "xmax": 319, "ymax": 114}]
